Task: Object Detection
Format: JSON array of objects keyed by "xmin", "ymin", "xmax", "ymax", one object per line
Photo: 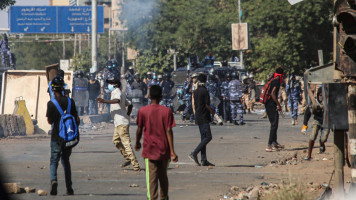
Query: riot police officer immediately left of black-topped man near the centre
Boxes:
[{"xmin": 182, "ymin": 74, "xmax": 194, "ymax": 123}]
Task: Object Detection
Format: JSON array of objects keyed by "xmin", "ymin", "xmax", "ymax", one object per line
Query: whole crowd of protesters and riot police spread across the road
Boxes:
[{"xmin": 47, "ymin": 61, "xmax": 329, "ymax": 199}]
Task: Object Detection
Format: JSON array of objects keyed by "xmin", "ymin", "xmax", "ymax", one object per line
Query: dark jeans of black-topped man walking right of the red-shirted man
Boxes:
[{"xmin": 193, "ymin": 124, "xmax": 213, "ymax": 163}]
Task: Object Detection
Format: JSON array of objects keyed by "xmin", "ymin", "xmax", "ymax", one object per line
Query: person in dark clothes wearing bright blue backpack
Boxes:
[{"xmin": 46, "ymin": 76, "xmax": 80, "ymax": 195}]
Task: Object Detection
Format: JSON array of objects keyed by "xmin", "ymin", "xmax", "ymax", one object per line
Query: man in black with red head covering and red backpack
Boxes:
[{"xmin": 265, "ymin": 67, "xmax": 283, "ymax": 152}]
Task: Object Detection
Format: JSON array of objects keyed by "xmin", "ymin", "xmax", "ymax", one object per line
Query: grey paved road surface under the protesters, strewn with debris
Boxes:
[{"xmin": 0, "ymin": 111, "xmax": 332, "ymax": 200}]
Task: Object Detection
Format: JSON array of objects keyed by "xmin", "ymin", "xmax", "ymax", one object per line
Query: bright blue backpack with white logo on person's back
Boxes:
[{"xmin": 51, "ymin": 97, "xmax": 79, "ymax": 148}]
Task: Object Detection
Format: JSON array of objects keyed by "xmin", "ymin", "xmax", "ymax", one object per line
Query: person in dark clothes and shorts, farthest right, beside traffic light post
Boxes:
[{"xmin": 304, "ymin": 87, "xmax": 330, "ymax": 160}]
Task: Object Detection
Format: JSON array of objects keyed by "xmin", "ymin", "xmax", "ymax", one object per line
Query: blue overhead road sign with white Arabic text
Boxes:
[{"xmin": 9, "ymin": 6, "xmax": 104, "ymax": 34}]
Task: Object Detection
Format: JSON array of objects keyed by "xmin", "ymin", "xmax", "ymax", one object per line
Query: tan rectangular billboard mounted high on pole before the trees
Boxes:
[{"xmin": 231, "ymin": 23, "xmax": 248, "ymax": 50}]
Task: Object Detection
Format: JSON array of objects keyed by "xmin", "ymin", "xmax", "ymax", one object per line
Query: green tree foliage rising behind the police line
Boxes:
[{"xmin": 121, "ymin": 0, "xmax": 332, "ymax": 79}]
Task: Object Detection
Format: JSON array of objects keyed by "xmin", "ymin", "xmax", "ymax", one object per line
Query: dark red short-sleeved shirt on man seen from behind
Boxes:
[{"xmin": 136, "ymin": 105, "xmax": 176, "ymax": 160}]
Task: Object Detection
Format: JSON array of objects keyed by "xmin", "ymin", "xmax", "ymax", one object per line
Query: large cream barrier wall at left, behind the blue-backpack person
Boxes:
[{"xmin": 0, "ymin": 70, "xmax": 73, "ymax": 133}]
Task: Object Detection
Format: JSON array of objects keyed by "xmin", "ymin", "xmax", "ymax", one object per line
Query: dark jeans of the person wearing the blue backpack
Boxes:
[{"xmin": 50, "ymin": 141, "xmax": 72, "ymax": 189}]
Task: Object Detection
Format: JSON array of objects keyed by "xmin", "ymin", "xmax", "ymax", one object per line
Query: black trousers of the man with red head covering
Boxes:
[{"xmin": 265, "ymin": 100, "xmax": 279, "ymax": 145}]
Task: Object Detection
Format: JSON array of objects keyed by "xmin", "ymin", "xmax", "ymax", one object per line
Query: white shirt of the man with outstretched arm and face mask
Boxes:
[{"xmin": 110, "ymin": 88, "xmax": 131, "ymax": 127}]
